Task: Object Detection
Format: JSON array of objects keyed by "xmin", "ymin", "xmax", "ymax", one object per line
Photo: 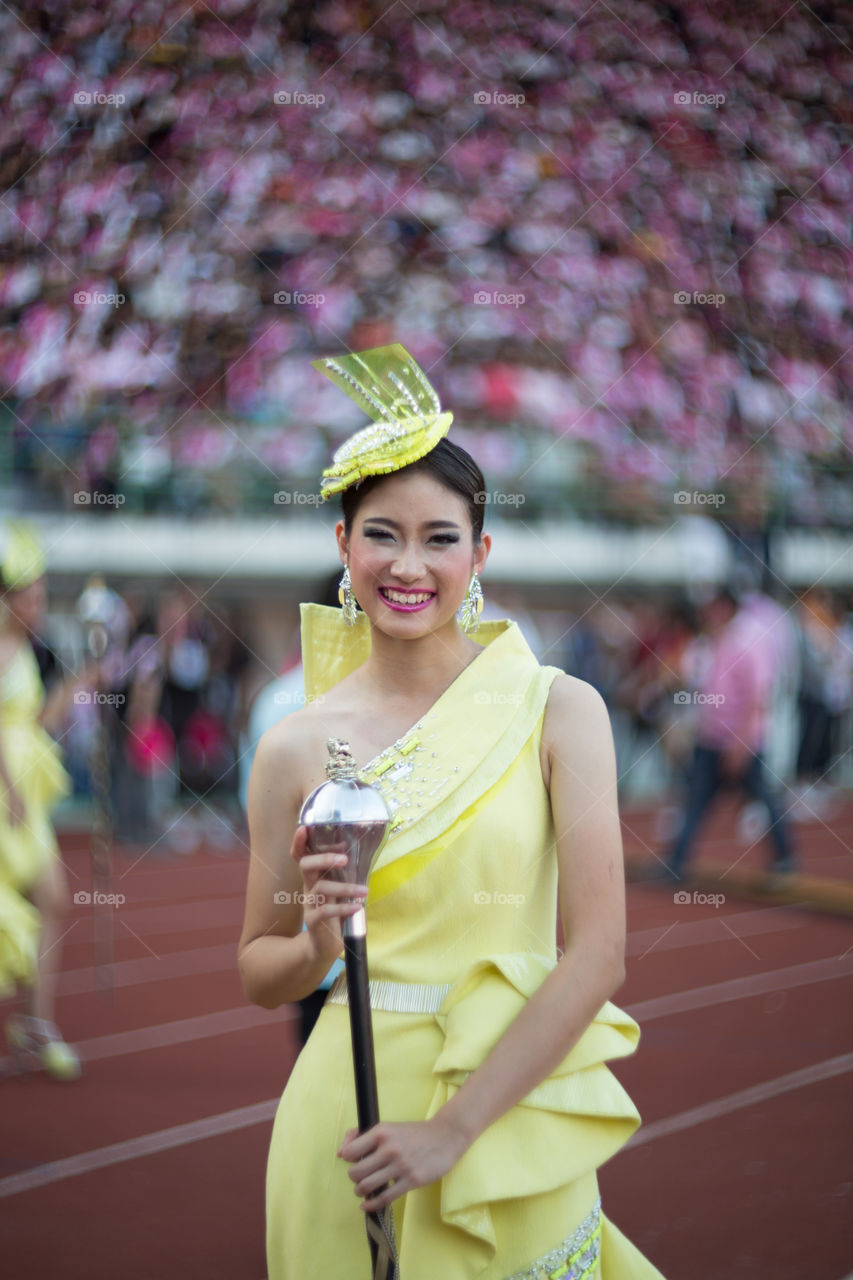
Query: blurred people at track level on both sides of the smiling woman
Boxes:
[{"xmin": 37, "ymin": 575, "xmax": 853, "ymax": 855}]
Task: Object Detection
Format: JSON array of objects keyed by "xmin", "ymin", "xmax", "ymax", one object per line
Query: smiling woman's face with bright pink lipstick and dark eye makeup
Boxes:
[{"xmin": 337, "ymin": 471, "xmax": 491, "ymax": 637}]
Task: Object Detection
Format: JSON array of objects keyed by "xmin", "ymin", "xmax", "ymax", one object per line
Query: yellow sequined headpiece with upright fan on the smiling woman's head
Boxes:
[{"xmin": 313, "ymin": 343, "xmax": 453, "ymax": 498}]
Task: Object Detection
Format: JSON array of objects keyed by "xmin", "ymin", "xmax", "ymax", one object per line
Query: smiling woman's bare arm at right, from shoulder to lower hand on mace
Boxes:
[{"xmin": 342, "ymin": 676, "xmax": 625, "ymax": 1210}]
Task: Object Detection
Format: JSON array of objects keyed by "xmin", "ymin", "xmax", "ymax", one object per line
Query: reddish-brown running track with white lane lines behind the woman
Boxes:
[{"xmin": 0, "ymin": 803, "xmax": 853, "ymax": 1280}]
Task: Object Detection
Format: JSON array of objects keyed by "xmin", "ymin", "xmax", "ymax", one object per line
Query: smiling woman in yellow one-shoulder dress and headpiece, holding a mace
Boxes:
[{"xmin": 240, "ymin": 347, "xmax": 660, "ymax": 1280}]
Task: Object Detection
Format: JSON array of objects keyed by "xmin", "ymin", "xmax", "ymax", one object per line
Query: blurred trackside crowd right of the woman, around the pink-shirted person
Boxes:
[{"xmin": 555, "ymin": 586, "xmax": 853, "ymax": 833}]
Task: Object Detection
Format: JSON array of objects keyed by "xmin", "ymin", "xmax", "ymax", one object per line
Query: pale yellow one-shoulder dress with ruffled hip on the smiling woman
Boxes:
[{"xmin": 266, "ymin": 605, "xmax": 662, "ymax": 1280}]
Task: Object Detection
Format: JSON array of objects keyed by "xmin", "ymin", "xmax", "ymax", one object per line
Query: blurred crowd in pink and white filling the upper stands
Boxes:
[{"xmin": 0, "ymin": 0, "xmax": 853, "ymax": 525}]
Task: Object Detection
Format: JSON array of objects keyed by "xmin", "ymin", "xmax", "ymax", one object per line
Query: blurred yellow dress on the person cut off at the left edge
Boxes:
[{"xmin": 0, "ymin": 644, "xmax": 70, "ymax": 995}]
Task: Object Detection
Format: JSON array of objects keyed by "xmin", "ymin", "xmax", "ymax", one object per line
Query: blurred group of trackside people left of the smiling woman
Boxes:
[{"xmin": 60, "ymin": 579, "xmax": 251, "ymax": 854}]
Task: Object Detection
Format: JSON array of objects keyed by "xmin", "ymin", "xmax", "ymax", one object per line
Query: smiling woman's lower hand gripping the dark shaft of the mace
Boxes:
[{"xmin": 338, "ymin": 1115, "xmax": 467, "ymax": 1213}]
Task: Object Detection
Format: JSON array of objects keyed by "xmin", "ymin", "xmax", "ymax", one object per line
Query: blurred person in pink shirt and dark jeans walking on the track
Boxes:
[{"xmin": 663, "ymin": 589, "xmax": 794, "ymax": 879}]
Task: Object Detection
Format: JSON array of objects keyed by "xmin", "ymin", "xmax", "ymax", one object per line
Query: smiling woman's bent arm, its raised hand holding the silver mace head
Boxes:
[{"xmin": 237, "ymin": 713, "xmax": 368, "ymax": 1009}]
